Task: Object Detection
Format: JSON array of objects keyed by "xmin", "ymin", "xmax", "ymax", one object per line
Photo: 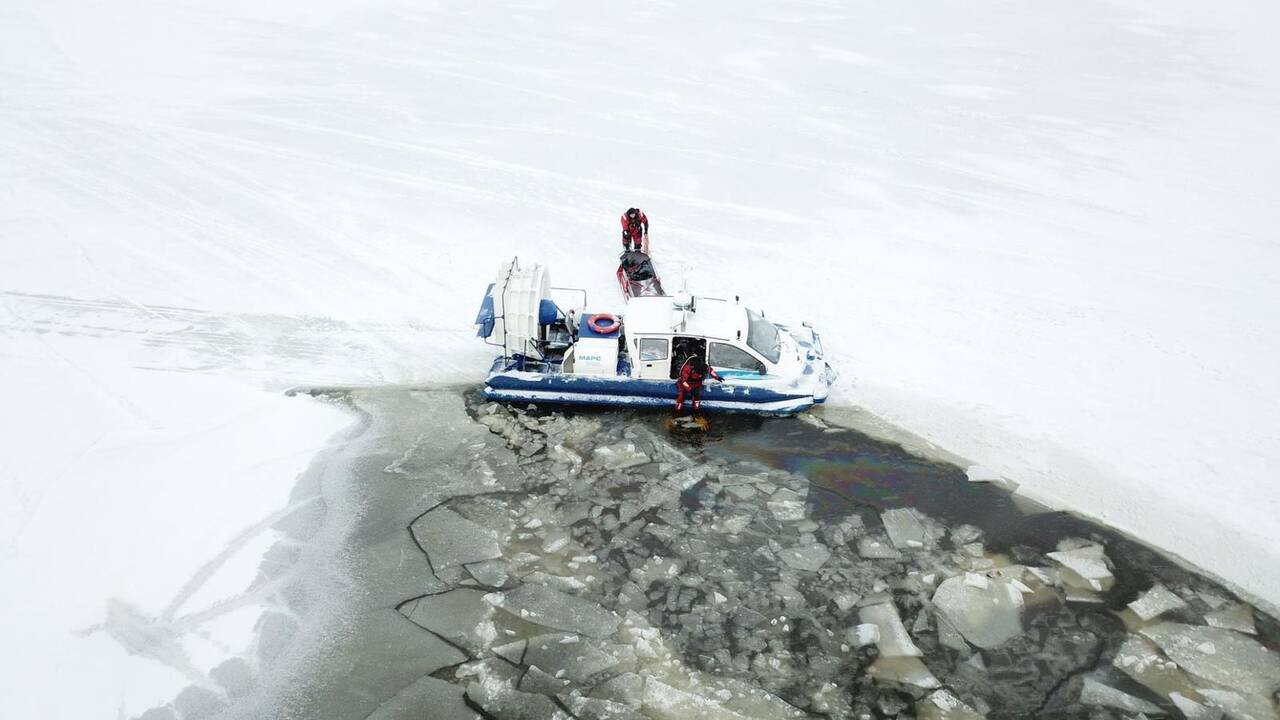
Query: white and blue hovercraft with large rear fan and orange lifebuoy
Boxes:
[{"xmin": 476, "ymin": 260, "xmax": 836, "ymax": 415}]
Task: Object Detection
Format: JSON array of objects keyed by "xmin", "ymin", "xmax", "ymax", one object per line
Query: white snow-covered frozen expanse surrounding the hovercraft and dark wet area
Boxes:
[{"xmin": 0, "ymin": 0, "xmax": 1280, "ymax": 717}]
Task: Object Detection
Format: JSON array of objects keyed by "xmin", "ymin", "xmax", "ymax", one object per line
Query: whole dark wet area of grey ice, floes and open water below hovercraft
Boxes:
[{"xmin": 135, "ymin": 391, "xmax": 1280, "ymax": 720}]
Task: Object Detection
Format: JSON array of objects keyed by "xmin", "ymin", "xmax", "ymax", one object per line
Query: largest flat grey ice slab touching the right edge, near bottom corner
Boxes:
[{"xmin": 1138, "ymin": 623, "xmax": 1280, "ymax": 691}]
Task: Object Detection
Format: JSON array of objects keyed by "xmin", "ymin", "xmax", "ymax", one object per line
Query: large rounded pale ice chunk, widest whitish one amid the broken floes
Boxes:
[{"xmin": 933, "ymin": 573, "xmax": 1024, "ymax": 650}]
